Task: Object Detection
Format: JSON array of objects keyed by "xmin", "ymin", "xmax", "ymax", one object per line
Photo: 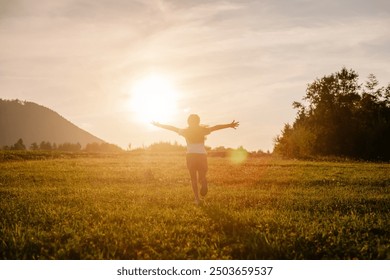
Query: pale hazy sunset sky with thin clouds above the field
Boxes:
[{"xmin": 0, "ymin": 0, "xmax": 390, "ymax": 151}]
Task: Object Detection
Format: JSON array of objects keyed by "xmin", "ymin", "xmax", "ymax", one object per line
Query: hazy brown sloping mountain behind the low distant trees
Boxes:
[{"xmin": 0, "ymin": 99, "xmax": 105, "ymax": 148}]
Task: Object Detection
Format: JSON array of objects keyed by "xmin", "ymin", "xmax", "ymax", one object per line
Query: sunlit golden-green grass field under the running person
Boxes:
[{"xmin": 0, "ymin": 152, "xmax": 390, "ymax": 259}]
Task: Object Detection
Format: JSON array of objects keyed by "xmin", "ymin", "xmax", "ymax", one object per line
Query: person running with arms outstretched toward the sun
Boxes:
[{"xmin": 152, "ymin": 114, "xmax": 239, "ymax": 204}]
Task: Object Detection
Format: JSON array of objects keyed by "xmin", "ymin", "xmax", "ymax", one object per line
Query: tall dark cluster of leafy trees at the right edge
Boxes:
[{"xmin": 274, "ymin": 67, "xmax": 390, "ymax": 160}]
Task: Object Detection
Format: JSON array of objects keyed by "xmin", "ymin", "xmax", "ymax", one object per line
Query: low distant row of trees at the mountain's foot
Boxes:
[{"xmin": 3, "ymin": 138, "xmax": 123, "ymax": 152}]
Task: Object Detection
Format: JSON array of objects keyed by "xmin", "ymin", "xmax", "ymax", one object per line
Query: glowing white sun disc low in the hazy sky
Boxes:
[{"xmin": 130, "ymin": 75, "xmax": 177, "ymax": 122}]
